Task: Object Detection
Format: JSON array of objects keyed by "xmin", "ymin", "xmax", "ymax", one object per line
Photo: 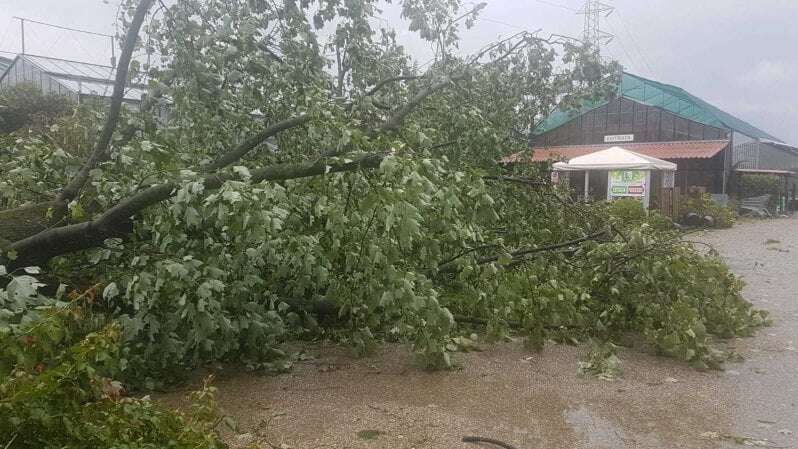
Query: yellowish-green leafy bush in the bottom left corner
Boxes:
[{"xmin": 0, "ymin": 275, "xmax": 233, "ymax": 448}]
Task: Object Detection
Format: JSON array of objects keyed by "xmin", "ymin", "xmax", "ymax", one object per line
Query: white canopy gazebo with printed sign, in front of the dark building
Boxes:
[{"xmin": 552, "ymin": 147, "xmax": 676, "ymax": 209}]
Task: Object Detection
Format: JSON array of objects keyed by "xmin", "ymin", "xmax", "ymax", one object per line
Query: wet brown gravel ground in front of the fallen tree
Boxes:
[{"xmin": 161, "ymin": 215, "xmax": 798, "ymax": 449}]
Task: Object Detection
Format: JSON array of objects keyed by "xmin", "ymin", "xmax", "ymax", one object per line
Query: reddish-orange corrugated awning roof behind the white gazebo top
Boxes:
[{"xmin": 502, "ymin": 140, "xmax": 729, "ymax": 163}]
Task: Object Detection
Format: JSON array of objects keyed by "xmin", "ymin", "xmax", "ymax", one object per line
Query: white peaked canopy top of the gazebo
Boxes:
[{"xmin": 552, "ymin": 147, "xmax": 676, "ymax": 171}]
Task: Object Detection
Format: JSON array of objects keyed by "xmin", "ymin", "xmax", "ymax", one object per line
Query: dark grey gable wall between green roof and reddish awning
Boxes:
[{"xmin": 533, "ymin": 97, "xmax": 728, "ymax": 146}]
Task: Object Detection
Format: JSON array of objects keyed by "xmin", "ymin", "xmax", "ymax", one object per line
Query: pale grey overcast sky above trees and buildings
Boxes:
[{"xmin": 0, "ymin": 0, "xmax": 798, "ymax": 145}]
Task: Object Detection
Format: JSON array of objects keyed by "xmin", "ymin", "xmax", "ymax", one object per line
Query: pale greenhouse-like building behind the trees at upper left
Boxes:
[{"xmin": 0, "ymin": 54, "xmax": 147, "ymax": 105}]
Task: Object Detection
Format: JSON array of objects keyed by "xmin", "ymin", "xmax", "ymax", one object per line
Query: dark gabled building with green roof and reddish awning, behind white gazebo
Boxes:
[{"xmin": 504, "ymin": 72, "xmax": 798, "ymax": 201}]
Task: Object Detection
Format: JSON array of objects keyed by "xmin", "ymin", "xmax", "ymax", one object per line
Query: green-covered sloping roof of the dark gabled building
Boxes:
[{"xmin": 535, "ymin": 72, "xmax": 780, "ymax": 141}]
